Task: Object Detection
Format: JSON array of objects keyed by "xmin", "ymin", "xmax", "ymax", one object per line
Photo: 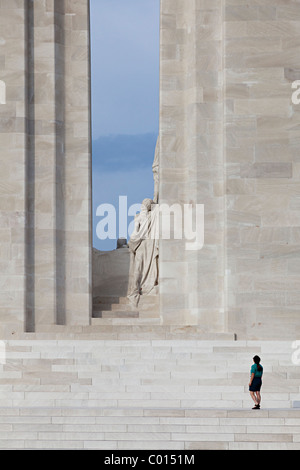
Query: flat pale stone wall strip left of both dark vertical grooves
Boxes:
[{"xmin": 0, "ymin": 0, "xmax": 26, "ymax": 336}]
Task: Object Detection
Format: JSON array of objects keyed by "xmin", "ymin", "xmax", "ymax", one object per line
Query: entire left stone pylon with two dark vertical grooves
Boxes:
[{"xmin": 0, "ymin": 0, "xmax": 92, "ymax": 331}]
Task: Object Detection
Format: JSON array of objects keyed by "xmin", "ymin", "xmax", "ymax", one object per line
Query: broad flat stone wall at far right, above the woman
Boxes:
[{"xmin": 224, "ymin": 0, "xmax": 300, "ymax": 338}]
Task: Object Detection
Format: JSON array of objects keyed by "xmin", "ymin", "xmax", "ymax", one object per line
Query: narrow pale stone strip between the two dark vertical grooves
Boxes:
[{"xmin": 29, "ymin": 0, "xmax": 57, "ymax": 326}]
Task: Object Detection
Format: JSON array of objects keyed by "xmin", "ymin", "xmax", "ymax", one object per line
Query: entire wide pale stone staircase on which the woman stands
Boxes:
[{"xmin": 0, "ymin": 335, "xmax": 300, "ymax": 450}]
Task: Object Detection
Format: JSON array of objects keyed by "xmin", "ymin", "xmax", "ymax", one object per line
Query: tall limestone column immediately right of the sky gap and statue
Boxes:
[{"xmin": 160, "ymin": 0, "xmax": 226, "ymax": 332}]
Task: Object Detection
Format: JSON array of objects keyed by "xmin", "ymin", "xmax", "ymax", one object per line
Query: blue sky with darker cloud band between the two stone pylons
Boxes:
[{"xmin": 91, "ymin": 0, "xmax": 159, "ymax": 250}]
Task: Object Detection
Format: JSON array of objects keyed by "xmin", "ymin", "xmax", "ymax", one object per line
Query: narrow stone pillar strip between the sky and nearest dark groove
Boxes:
[{"xmin": 63, "ymin": 0, "xmax": 92, "ymax": 325}]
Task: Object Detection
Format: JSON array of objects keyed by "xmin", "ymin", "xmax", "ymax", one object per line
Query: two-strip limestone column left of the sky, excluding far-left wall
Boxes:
[{"xmin": 32, "ymin": 0, "xmax": 91, "ymax": 325}]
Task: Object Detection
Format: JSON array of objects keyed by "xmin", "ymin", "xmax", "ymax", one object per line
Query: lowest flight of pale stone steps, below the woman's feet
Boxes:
[{"xmin": 0, "ymin": 407, "xmax": 300, "ymax": 451}]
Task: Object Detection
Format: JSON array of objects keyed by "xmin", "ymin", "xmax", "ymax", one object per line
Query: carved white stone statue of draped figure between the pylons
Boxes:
[{"xmin": 128, "ymin": 199, "xmax": 159, "ymax": 307}]
